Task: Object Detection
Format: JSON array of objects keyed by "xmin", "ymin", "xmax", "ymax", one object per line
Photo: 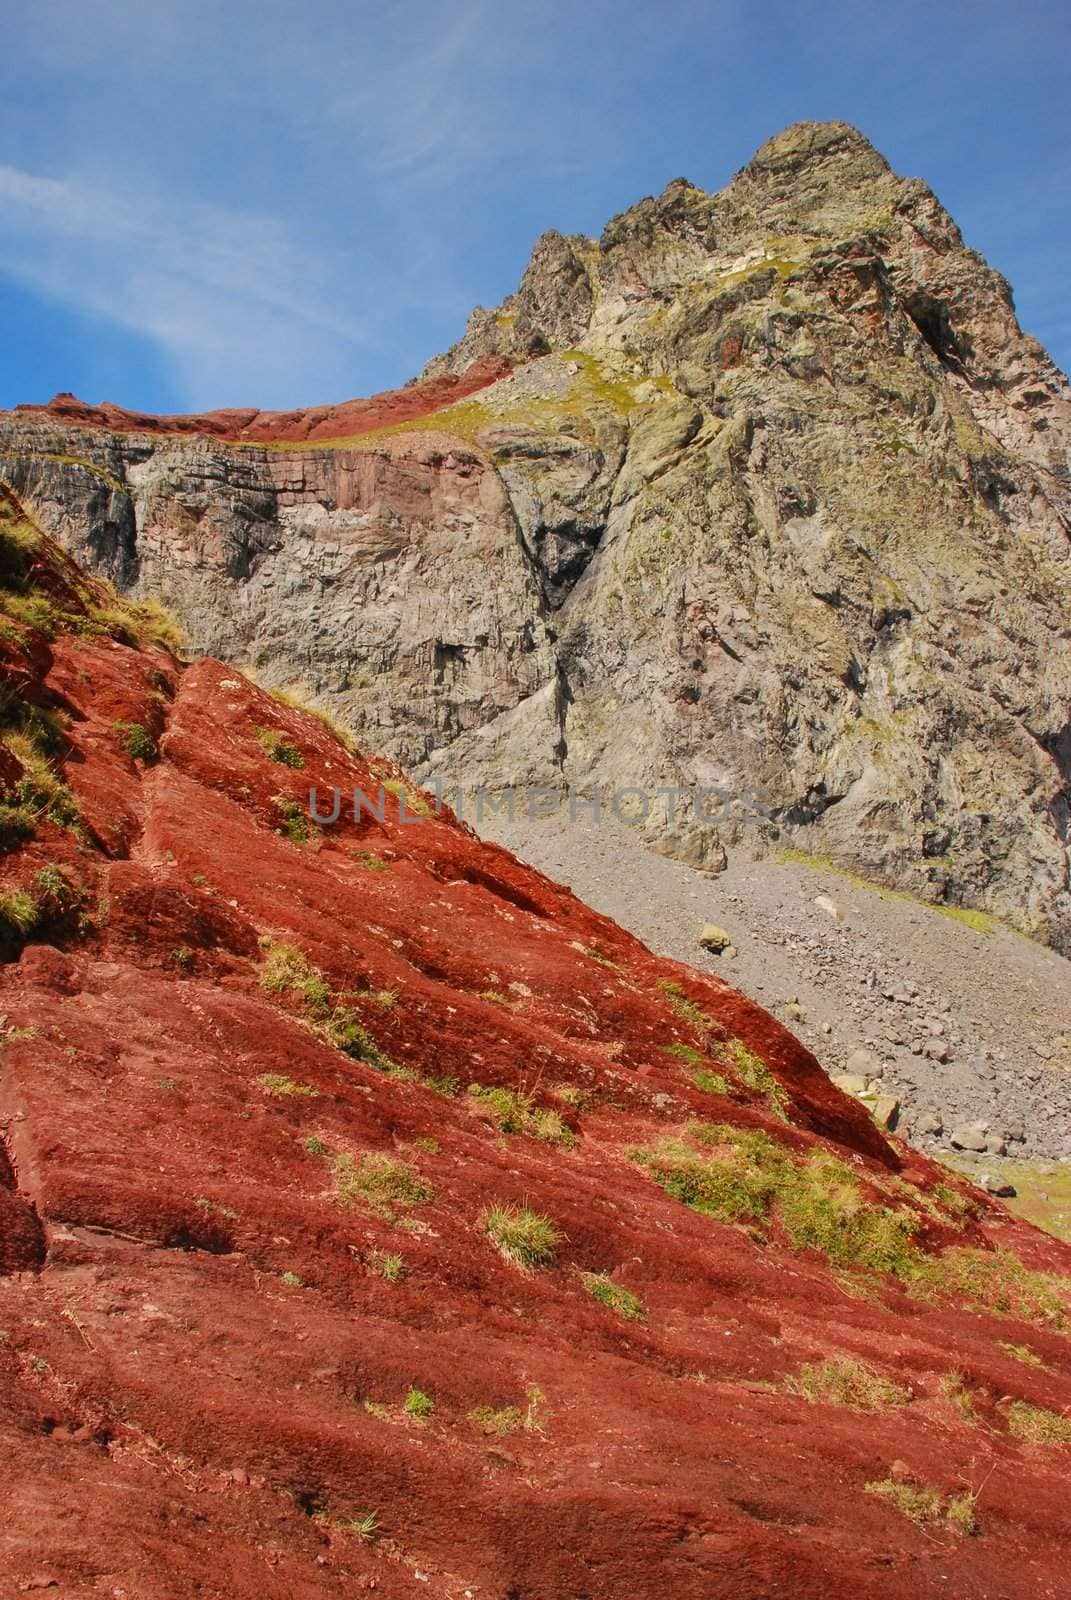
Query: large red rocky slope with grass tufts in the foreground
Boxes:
[{"xmin": 0, "ymin": 492, "xmax": 1071, "ymax": 1600}]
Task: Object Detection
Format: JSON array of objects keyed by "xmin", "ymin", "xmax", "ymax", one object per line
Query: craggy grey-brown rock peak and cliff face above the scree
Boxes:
[{"xmin": 0, "ymin": 123, "xmax": 1071, "ymax": 950}]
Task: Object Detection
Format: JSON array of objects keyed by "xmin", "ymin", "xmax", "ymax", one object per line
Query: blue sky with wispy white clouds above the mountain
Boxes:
[{"xmin": 0, "ymin": 0, "xmax": 1071, "ymax": 411}]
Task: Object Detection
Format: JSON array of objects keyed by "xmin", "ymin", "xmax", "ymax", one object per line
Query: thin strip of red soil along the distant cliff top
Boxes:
[{"xmin": 14, "ymin": 355, "xmax": 512, "ymax": 445}]
